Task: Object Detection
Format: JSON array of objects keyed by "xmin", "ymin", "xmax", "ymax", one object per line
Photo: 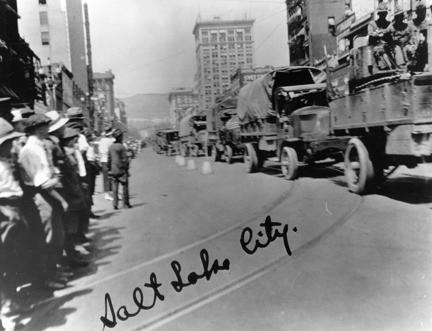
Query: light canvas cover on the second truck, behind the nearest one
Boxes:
[{"xmin": 237, "ymin": 67, "xmax": 326, "ymax": 124}]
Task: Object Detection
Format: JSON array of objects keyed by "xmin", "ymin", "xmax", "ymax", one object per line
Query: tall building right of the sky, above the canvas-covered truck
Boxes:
[{"xmin": 286, "ymin": 0, "xmax": 351, "ymax": 65}]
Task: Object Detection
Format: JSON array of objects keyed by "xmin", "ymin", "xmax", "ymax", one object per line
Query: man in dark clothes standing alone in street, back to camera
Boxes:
[{"xmin": 108, "ymin": 129, "xmax": 132, "ymax": 209}]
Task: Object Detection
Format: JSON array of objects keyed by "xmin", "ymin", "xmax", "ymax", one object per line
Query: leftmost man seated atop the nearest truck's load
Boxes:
[{"xmin": 368, "ymin": 2, "xmax": 394, "ymax": 75}]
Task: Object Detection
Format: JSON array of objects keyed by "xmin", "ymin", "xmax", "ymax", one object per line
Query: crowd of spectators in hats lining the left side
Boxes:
[{"xmin": 0, "ymin": 107, "xmax": 131, "ymax": 330}]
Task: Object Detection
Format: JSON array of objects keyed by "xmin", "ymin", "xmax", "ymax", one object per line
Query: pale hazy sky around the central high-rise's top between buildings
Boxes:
[{"xmin": 83, "ymin": 0, "xmax": 288, "ymax": 97}]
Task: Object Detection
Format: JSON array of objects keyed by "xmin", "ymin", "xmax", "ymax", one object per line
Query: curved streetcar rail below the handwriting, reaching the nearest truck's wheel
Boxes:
[{"xmin": 128, "ymin": 197, "xmax": 365, "ymax": 331}]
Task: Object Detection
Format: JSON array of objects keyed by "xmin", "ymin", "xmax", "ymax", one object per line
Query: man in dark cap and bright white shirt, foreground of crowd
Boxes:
[{"xmin": 18, "ymin": 114, "xmax": 68, "ymax": 288}]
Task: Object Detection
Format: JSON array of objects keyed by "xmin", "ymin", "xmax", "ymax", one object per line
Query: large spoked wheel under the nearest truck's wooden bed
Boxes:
[{"xmin": 344, "ymin": 138, "xmax": 374, "ymax": 194}]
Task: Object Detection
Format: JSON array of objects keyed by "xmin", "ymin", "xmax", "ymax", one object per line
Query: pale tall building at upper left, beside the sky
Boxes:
[{"xmin": 18, "ymin": 0, "xmax": 88, "ymax": 92}]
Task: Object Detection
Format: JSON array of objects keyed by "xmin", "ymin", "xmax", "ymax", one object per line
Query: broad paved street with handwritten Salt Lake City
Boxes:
[{"xmin": 18, "ymin": 148, "xmax": 432, "ymax": 331}]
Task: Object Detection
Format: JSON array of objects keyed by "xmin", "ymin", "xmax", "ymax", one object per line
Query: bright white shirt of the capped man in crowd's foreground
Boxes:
[{"xmin": 18, "ymin": 136, "xmax": 58, "ymax": 189}]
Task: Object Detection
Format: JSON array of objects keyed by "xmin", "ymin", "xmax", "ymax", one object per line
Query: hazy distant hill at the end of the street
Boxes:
[{"xmin": 122, "ymin": 93, "xmax": 169, "ymax": 122}]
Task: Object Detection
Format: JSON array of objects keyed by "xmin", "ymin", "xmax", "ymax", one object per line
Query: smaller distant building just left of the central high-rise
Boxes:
[{"xmin": 168, "ymin": 87, "xmax": 199, "ymax": 128}]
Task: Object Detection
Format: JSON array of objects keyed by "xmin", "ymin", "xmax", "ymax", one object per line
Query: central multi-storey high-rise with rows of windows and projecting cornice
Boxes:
[{"xmin": 192, "ymin": 17, "xmax": 255, "ymax": 110}]
